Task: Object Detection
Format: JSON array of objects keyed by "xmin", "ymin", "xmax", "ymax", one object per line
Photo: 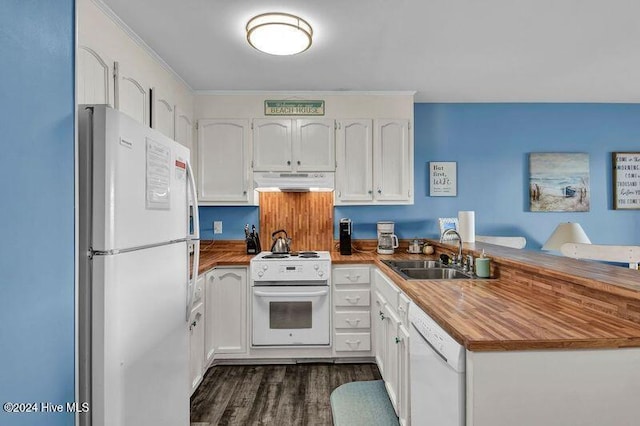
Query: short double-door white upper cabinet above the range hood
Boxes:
[{"xmin": 253, "ymin": 118, "xmax": 335, "ymax": 172}]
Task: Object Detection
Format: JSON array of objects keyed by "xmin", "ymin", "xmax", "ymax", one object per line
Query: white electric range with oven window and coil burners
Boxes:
[{"xmin": 250, "ymin": 251, "xmax": 331, "ymax": 347}]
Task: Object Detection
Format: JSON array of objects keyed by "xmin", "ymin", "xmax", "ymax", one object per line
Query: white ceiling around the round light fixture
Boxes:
[{"xmin": 103, "ymin": 0, "xmax": 640, "ymax": 102}]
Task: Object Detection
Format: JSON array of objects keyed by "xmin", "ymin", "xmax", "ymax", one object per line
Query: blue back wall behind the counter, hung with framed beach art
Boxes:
[{"xmin": 202, "ymin": 103, "xmax": 640, "ymax": 249}]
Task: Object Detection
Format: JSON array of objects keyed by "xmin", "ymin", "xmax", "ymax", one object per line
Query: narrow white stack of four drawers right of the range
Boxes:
[{"xmin": 332, "ymin": 265, "xmax": 371, "ymax": 358}]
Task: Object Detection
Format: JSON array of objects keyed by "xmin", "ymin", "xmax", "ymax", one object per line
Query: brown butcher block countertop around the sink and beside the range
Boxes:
[{"xmin": 200, "ymin": 241, "xmax": 640, "ymax": 351}]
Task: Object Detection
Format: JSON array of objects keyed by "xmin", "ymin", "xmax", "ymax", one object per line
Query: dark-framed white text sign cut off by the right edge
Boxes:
[{"xmin": 612, "ymin": 152, "xmax": 640, "ymax": 210}]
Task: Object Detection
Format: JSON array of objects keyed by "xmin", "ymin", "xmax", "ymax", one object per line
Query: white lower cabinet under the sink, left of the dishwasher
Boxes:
[{"xmin": 371, "ymin": 269, "xmax": 411, "ymax": 425}]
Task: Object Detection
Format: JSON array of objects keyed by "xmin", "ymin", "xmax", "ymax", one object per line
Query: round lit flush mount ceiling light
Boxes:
[{"xmin": 247, "ymin": 13, "xmax": 313, "ymax": 55}]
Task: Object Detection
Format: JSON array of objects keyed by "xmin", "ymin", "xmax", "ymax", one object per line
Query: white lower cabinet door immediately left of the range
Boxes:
[{"xmin": 205, "ymin": 268, "xmax": 249, "ymax": 365}]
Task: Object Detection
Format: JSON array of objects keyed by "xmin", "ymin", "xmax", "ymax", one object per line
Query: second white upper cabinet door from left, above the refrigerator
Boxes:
[{"xmin": 115, "ymin": 62, "xmax": 150, "ymax": 126}]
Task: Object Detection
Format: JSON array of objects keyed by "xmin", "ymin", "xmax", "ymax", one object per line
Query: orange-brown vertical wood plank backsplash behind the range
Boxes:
[{"xmin": 260, "ymin": 192, "xmax": 333, "ymax": 251}]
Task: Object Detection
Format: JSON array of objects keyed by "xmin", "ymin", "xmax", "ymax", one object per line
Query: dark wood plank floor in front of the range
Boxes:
[{"xmin": 191, "ymin": 364, "xmax": 380, "ymax": 426}]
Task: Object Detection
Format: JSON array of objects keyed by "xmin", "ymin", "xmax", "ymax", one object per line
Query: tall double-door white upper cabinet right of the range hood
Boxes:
[{"xmin": 335, "ymin": 119, "xmax": 413, "ymax": 204}]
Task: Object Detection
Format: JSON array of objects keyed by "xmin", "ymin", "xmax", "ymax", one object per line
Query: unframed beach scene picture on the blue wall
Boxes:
[{"xmin": 529, "ymin": 152, "xmax": 591, "ymax": 212}]
